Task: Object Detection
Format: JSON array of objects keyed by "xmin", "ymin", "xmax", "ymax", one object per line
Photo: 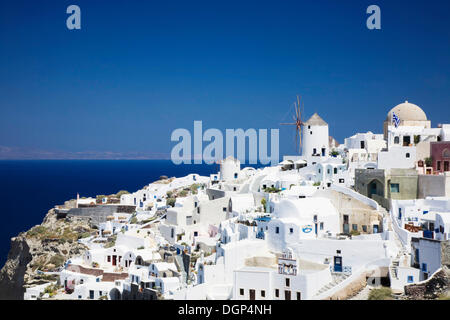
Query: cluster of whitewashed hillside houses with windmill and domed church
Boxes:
[{"xmin": 25, "ymin": 102, "xmax": 450, "ymax": 300}]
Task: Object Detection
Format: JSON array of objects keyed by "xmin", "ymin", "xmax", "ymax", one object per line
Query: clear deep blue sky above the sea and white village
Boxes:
[{"xmin": 0, "ymin": 0, "xmax": 450, "ymax": 159}]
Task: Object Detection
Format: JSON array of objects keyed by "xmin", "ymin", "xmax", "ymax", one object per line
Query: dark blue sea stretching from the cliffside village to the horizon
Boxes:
[{"xmin": 0, "ymin": 160, "xmax": 239, "ymax": 266}]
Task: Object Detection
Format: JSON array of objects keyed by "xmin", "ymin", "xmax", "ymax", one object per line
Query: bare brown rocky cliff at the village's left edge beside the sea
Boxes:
[{"xmin": 0, "ymin": 209, "xmax": 91, "ymax": 300}]
